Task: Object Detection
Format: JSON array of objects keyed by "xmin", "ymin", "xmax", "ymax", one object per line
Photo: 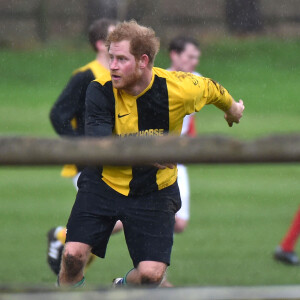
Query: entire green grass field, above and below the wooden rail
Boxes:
[{"xmin": 0, "ymin": 40, "xmax": 300, "ymax": 286}]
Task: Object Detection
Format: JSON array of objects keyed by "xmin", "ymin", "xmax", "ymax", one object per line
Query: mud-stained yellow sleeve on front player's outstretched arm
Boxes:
[{"xmin": 178, "ymin": 73, "xmax": 233, "ymax": 114}]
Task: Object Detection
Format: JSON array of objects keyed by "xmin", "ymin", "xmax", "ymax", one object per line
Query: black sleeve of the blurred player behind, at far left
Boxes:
[{"xmin": 50, "ymin": 70, "xmax": 94, "ymax": 136}]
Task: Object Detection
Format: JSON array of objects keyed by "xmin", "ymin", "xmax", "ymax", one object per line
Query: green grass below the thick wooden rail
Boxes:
[{"xmin": 0, "ymin": 165, "xmax": 300, "ymax": 285}]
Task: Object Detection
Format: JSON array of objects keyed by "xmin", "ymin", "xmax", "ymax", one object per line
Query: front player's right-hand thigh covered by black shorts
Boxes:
[{"xmin": 121, "ymin": 183, "xmax": 181, "ymax": 267}]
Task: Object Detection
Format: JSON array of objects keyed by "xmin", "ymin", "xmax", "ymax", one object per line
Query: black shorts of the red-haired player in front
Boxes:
[{"xmin": 66, "ymin": 169, "xmax": 181, "ymax": 267}]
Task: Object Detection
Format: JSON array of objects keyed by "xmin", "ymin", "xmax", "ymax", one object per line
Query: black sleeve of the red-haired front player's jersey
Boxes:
[{"xmin": 85, "ymin": 81, "xmax": 115, "ymax": 137}]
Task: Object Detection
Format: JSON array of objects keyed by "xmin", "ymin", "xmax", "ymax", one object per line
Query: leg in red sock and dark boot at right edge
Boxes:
[{"xmin": 274, "ymin": 208, "xmax": 300, "ymax": 266}]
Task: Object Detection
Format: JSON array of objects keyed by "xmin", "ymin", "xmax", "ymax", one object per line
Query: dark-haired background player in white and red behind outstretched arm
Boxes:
[{"xmin": 168, "ymin": 36, "xmax": 202, "ymax": 233}]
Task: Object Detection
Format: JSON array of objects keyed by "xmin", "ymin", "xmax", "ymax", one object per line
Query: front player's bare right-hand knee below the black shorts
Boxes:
[{"xmin": 138, "ymin": 262, "xmax": 167, "ymax": 285}]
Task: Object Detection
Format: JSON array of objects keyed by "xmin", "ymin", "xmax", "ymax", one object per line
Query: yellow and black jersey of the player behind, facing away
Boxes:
[{"xmin": 50, "ymin": 60, "xmax": 109, "ymax": 177}]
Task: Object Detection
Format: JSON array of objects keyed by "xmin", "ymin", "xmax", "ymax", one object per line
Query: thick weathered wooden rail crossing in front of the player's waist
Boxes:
[{"xmin": 0, "ymin": 134, "xmax": 300, "ymax": 166}]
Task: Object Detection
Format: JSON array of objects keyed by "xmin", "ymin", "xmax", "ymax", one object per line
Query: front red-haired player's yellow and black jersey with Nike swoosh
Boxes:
[{"xmin": 85, "ymin": 68, "xmax": 232, "ymax": 196}]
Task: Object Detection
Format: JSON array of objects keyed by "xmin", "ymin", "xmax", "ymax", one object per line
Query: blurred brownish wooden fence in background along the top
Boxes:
[{"xmin": 0, "ymin": 0, "xmax": 300, "ymax": 45}]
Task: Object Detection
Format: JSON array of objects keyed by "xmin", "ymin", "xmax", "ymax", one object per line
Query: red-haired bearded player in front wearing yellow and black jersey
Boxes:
[{"xmin": 58, "ymin": 21, "xmax": 244, "ymax": 286}]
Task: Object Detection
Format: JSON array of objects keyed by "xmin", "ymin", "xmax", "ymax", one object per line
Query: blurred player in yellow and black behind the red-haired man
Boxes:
[{"xmin": 47, "ymin": 19, "xmax": 122, "ymax": 274}]
